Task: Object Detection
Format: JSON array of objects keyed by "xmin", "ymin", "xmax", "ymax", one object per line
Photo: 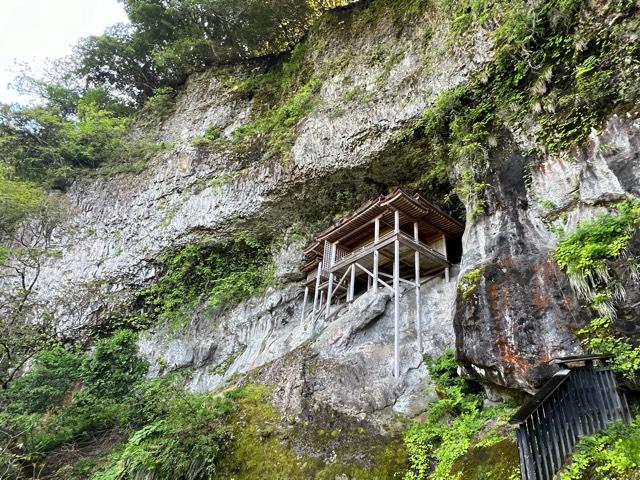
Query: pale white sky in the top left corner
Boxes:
[{"xmin": 0, "ymin": 0, "xmax": 127, "ymax": 103}]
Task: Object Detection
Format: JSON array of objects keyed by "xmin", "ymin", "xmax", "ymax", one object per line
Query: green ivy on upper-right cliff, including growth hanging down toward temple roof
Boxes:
[{"xmin": 397, "ymin": 0, "xmax": 640, "ymax": 217}]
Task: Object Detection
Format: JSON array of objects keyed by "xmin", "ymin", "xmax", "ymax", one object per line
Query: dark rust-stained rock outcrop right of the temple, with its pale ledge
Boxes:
[{"xmin": 455, "ymin": 116, "xmax": 640, "ymax": 391}]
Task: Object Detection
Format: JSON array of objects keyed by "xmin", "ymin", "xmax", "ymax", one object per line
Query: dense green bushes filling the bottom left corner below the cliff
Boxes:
[{"xmin": 0, "ymin": 330, "xmax": 254, "ymax": 480}]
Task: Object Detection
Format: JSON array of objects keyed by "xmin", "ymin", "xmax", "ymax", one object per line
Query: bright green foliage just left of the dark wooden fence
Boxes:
[{"xmin": 404, "ymin": 350, "xmax": 519, "ymax": 480}]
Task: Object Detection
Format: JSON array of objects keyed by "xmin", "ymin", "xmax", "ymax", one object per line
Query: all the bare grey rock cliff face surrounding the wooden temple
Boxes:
[{"xmin": 26, "ymin": 2, "xmax": 640, "ymax": 428}]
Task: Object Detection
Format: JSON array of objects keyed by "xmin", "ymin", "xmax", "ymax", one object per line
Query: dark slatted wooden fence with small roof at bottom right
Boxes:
[{"xmin": 510, "ymin": 356, "xmax": 631, "ymax": 480}]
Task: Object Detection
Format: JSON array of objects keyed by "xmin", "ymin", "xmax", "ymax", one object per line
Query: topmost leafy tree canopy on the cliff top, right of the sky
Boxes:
[{"xmin": 76, "ymin": 0, "xmax": 349, "ymax": 104}]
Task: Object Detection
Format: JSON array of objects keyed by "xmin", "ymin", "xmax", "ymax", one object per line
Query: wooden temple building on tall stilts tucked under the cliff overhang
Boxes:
[{"xmin": 302, "ymin": 189, "xmax": 464, "ymax": 377}]
